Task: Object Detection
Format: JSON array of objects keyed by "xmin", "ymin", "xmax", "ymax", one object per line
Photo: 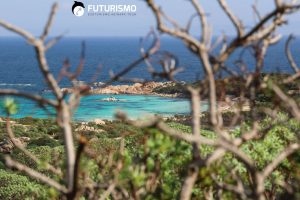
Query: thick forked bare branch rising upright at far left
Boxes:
[{"xmin": 0, "ymin": 4, "xmax": 75, "ymax": 194}]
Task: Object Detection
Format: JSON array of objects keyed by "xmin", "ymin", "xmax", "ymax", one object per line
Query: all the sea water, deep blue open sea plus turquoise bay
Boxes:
[{"xmin": 0, "ymin": 37, "xmax": 300, "ymax": 119}]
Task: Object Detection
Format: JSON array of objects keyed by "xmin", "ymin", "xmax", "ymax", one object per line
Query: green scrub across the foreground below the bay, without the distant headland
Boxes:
[{"xmin": 0, "ymin": 113, "xmax": 300, "ymax": 200}]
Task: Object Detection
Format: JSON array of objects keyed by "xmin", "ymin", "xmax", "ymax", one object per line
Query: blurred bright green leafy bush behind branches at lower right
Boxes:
[{"xmin": 110, "ymin": 117, "xmax": 299, "ymax": 199}]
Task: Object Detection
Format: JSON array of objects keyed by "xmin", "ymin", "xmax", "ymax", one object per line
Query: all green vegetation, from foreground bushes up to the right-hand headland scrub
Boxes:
[{"xmin": 0, "ymin": 74, "xmax": 300, "ymax": 200}]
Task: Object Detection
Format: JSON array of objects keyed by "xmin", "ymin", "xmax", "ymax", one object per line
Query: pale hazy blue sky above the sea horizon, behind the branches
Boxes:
[{"xmin": 0, "ymin": 0, "xmax": 300, "ymax": 36}]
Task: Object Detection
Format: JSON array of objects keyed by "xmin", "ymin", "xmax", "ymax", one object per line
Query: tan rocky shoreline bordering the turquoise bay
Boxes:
[{"xmin": 0, "ymin": 81, "xmax": 249, "ymax": 122}]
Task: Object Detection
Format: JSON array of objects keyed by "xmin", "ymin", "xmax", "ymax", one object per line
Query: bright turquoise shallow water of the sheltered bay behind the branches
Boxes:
[{"xmin": 0, "ymin": 95, "xmax": 207, "ymax": 121}]
